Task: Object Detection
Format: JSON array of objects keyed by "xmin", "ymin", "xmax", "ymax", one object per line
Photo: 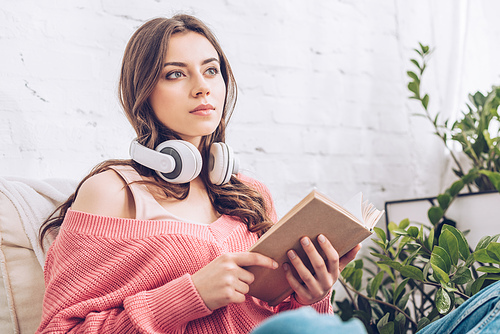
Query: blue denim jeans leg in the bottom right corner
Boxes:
[{"xmin": 417, "ymin": 281, "xmax": 500, "ymax": 334}]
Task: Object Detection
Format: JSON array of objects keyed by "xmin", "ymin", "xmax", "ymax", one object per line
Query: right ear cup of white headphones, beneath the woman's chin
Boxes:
[{"xmin": 208, "ymin": 143, "xmax": 234, "ymax": 185}]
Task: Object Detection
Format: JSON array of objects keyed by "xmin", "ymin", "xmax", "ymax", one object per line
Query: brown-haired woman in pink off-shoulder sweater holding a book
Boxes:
[{"xmin": 38, "ymin": 15, "xmax": 359, "ymax": 333}]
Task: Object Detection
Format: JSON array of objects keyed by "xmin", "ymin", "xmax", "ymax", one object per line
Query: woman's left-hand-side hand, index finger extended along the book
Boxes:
[{"xmin": 192, "ymin": 253, "xmax": 278, "ymax": 311}]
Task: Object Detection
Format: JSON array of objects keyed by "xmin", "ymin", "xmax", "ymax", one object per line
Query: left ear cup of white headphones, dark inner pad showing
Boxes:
[{"xmin": 156, "ymin": 140, "xmax": 203, "ymax": 183}]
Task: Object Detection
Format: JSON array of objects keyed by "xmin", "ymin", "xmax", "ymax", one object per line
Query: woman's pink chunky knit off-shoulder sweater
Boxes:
[{"xmin": 38, "ymin": 184, "xmax": 332, "ymax": 333}]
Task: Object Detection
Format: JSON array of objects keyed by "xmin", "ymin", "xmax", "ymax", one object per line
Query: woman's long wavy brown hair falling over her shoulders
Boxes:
[{"xmin": 40, "ymin": 15, "xmax": 272, "ymax": 243}]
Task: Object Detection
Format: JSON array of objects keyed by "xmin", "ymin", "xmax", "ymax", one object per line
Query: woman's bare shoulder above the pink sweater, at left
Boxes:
[{"xmin": 71, "ymin": 170, "xmax": 135, "ymax": 218}]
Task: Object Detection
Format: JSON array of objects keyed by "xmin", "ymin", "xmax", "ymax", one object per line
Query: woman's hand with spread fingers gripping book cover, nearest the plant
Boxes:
[{"xmin": 283, "ymin": 234, "xmax": 361, "ymax": 305}]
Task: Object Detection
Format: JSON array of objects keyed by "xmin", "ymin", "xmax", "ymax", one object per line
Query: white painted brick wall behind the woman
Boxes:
[{"xmin": 0, "ymin": 0, "xmax": 500, "ymax": 219}]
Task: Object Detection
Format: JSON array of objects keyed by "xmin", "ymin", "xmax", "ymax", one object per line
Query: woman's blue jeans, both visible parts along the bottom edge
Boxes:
[{"xmin": 251, "ymin": 281, "xmax": 500, "ymax": 334}]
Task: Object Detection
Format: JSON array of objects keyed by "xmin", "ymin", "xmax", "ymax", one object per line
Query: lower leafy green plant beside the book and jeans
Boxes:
[{"xmin": 337, "ymin": 219, "xmax": 500, "ymax": 333}]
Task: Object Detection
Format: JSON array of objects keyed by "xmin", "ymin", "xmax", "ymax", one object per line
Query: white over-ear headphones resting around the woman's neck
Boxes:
[{"xmin": 130, "ymin": 140, "xmax": 239, "ymax": 185}]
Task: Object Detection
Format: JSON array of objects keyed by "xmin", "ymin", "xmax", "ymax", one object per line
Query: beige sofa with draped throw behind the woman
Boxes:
[{"xmin": 0, "ymin": 178, "xmax": 76, "ymax": 334}]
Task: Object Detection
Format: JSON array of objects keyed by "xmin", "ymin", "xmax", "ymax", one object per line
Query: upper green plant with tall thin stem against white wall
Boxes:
[{"xmin": 407, "ymin": 43, "xmax": 500, "ymax": 224}]
